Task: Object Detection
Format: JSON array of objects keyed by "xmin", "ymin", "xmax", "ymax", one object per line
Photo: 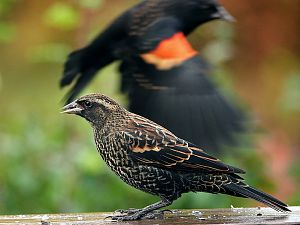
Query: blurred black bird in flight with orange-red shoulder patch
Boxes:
[{"xmin": 60, "ymin": 0, "xmax": 243, "ymax": 149}]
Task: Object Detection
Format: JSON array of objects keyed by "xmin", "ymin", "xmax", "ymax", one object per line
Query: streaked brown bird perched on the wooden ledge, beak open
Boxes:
[{"xmin": 63, "ymin": 94, "xmax": 290, "ymax": 220}]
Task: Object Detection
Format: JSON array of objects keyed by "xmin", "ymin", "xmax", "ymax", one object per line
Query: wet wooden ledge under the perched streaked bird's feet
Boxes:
[{"xmin": 0, "ymin": 207, "xmax": 300, "ymax": 225}]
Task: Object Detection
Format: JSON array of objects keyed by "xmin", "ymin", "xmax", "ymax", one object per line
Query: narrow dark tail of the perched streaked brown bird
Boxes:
[{"xmin": 224, "ymin": 181, "xmax": 291, "ymax": 212}]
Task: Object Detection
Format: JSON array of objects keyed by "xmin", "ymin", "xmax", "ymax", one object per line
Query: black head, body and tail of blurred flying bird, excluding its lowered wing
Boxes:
[{"xmin": 60, "ymin": 0, "xmax": 231, "ymax": 96}]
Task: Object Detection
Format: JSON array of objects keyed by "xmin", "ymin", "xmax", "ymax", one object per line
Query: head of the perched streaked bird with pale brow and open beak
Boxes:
[{"xmin": 62, "ymin": 94, "xmax": 123, "ymax": 127}]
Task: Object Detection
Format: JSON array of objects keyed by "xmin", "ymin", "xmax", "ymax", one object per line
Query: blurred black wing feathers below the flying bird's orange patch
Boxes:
[{"xmin": 123, "ymin": 55, "xmax": 244, "ymax": 151}]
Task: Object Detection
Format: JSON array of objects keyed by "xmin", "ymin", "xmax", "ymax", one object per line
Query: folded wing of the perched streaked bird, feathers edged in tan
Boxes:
[{"xmin": 122, "ymin": 115, "xmax": 244, "ymax": 173}]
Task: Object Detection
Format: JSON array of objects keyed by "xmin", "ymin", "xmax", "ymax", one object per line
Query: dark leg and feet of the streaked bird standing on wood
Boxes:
[{"xmin": 111, "ymin": 198, "xmax": 172, "ymax": 221}]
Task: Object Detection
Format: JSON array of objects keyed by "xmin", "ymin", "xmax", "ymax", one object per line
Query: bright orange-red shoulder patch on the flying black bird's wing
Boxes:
[{"xmin": 141, "ymin": 32, "xmax": 197, "ymax": 70}]
